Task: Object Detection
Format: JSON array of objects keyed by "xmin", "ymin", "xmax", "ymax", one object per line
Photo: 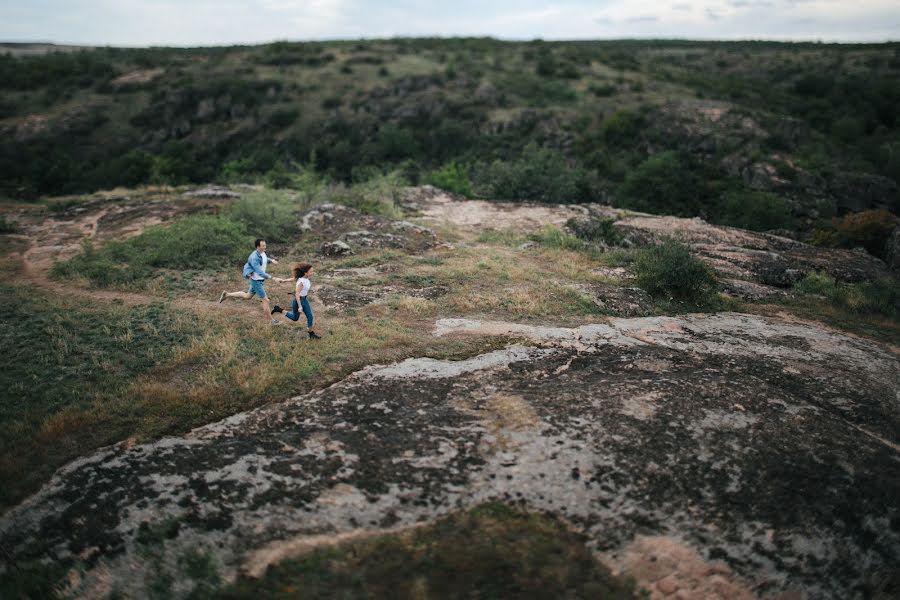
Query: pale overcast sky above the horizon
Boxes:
[{"xmin": 0, "ymin": 0, "xmax": 900, "ymax": 46}]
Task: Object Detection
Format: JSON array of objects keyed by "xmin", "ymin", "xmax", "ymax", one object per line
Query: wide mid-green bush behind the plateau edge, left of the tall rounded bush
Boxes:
[{"xmin": 479, "ymin": 143, "xmax": 597, "ymax": 203}]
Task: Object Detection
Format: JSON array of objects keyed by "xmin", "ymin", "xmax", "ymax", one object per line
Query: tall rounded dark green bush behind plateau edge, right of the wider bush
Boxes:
[{"xmin": 616, "ymin": 151, "xmax": 706, "ymax": 217}]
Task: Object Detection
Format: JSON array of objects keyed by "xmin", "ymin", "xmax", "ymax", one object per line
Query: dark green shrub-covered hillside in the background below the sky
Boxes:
[{"xmin": 0, "ymin": 38, "xmax": 900, "ymax": 241}]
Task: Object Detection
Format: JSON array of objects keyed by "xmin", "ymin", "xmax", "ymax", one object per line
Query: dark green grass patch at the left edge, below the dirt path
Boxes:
[{"xmin": 0, "ymin": 285, "xmax": 198, "ymax": 505}]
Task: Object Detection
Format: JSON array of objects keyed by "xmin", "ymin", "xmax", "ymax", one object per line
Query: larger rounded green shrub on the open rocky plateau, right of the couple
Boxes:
[{"xmin": 633, "ymin": 240, "xmax": 716, "ymax": 303}]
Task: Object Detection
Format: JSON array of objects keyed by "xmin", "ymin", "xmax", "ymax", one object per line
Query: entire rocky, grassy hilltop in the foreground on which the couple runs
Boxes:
[{"xmin": 0, "ymin": 184, "xmax": 900, "ymax": 598}]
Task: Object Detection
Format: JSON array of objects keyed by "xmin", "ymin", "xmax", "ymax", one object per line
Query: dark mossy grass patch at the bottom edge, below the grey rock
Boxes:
[{"xmin": 217, "ymin": 502, "xmax": 638, "ymax": 600}]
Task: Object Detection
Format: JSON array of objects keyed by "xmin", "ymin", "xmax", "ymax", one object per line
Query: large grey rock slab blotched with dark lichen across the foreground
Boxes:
[{"xmin": 0, "ymin": 313, "xmax": 900, "ymax": 598}]
